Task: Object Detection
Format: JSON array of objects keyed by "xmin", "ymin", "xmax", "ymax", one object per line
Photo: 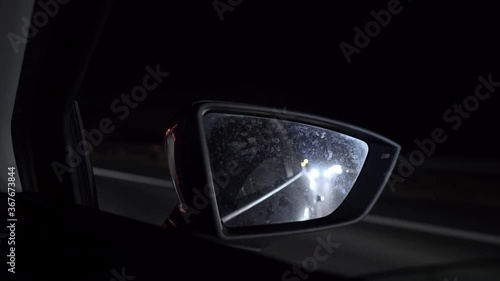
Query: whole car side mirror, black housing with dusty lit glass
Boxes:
[{"xmin": 165, "ymin": 102, "xmax": 400, "ymax": 239}]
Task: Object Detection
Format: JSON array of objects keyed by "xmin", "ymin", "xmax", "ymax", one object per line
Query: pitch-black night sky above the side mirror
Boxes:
[{"xmin": 80, "ymin": 0, "xmax": 500, "ymax": 157}]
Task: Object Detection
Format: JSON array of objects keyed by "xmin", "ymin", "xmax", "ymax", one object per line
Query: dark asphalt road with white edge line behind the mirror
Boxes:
[{"xmin": 94, "ymin": 152, "xmax": 500, "ymax": 276}]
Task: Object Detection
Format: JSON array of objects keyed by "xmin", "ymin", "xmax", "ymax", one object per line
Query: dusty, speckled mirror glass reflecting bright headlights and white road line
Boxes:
[{"xmin": 203, "ymin": 113, "xmax": 368, "ymax": 227}]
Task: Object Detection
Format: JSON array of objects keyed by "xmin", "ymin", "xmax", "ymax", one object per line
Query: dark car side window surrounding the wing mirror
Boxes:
[{"xmin": 78, "ymin": 1, "xmax": 500, "ymax": 280}]
